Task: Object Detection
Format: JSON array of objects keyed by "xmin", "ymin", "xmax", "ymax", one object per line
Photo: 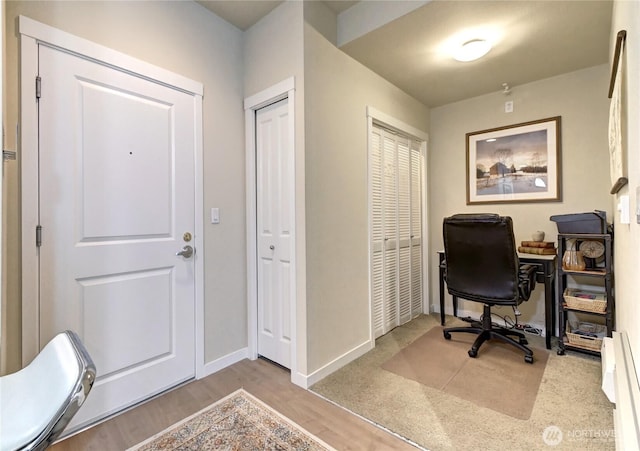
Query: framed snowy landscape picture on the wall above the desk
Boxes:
[{"xmin": 466, "ymin": 116, "xmax": 562, "ymax": 205}]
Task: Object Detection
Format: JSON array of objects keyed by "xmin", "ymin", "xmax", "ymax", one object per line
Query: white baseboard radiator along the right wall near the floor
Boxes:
[{"xmin": 602, "ymin": 332, "xmax": 640, "ymax": 451}]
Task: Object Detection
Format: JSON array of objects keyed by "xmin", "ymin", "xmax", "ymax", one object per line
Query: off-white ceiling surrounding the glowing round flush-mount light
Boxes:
[{"xmin": 198, "ymin": 0, "xmax": 613, "ymax": 107}]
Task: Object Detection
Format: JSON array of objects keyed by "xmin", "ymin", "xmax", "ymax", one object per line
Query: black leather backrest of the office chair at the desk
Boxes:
[{"xmin": 443, "ymin": 214, "xmax": 520, "ymax": 305}]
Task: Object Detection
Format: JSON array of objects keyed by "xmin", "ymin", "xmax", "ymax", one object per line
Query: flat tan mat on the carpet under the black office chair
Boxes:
[{"xmin": 382, "ymin": 326, "xmax": 549, "ymax": 420}]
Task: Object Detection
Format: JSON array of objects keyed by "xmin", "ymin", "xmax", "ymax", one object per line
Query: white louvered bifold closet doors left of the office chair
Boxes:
[{"xmin": 370, "ymin": 127, "xmax": 422, "ymax": 338}]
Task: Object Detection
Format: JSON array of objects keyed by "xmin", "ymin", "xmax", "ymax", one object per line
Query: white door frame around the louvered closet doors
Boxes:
[{"xmin": 367, "ymin": 106, "xmax": 430, "ymax": 348}]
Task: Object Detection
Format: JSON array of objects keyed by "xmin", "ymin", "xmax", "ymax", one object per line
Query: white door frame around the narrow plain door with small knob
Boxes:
[{"xmin": 244, "ymin": 77, "xmax": 307, "ymax": 388}]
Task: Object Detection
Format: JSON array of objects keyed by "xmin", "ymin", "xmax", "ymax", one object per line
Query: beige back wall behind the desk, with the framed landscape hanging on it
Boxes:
[{"xmin": 429, "ymin": 65, "xmax": 613, "ymax": 325}]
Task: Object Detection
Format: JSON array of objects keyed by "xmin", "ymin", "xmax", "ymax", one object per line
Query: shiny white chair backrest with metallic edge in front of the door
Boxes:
[{"xmin": 0, "ymin": 331, "xmax": 96, "ymax": 451}]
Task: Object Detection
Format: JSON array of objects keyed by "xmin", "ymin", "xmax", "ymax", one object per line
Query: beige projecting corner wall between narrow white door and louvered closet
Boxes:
[{"xmin": 244, "ymin": 2, "xmax": 428, "ymax": 376}]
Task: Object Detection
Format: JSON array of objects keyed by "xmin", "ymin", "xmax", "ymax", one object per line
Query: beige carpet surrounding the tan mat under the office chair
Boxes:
[{"xmin": 311, "ymin": 315, "xmax": 615, "ymax": 451}]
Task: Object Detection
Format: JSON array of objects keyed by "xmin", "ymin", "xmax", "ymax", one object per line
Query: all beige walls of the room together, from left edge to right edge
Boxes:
[{"xmin": 2, "ymin": 1, "xmax": 640, "ymax": 388}]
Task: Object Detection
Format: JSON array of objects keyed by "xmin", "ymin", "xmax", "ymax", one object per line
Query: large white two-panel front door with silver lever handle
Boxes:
[{"xmin": 38, "ymin": 45, "xmax": 196, "ymax": 428}]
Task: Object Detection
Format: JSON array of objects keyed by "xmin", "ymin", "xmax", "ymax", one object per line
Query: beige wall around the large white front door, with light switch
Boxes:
[{"xmin": 4, "ymin": 1, "xmax": 247, "ymax": 371}]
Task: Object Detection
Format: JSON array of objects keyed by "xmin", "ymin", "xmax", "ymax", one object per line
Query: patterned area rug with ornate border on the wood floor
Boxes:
[{"xmin": 129, "ymin": 389, "xmax": 335, "ymax": 451}]
